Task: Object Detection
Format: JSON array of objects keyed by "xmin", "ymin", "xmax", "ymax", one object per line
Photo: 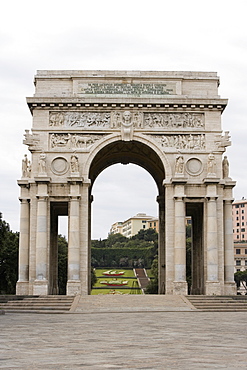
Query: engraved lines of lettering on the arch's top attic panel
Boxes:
[{"xmin": 78, "ymin": 82, "xmax": 176, "ymax": 96}]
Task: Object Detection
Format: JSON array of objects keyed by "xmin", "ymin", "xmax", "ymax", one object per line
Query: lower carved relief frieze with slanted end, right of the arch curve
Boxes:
[{"xmin": 150, "ymin": 134, "xmax": 206, "ymax": 151}]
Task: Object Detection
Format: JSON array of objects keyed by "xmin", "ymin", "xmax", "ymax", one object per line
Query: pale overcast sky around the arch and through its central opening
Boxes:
[{"xmin": 0, "ymin": 0, "xmax": 247, "ymax": 238}]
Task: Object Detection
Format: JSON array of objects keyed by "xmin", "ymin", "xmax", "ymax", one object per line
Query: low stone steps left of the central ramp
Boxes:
[{"xmin": 0, "ymin": 295, "xmax": 75, "ymax": 313}]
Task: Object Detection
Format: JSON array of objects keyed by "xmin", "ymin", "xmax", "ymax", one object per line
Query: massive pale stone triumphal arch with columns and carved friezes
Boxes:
[{"xmin": 17, "ymin": 71, "xmax": 235, "ymax": 295}]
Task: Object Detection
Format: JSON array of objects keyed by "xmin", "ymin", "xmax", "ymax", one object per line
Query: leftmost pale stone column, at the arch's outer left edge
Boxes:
[{"xmin": 16, "ymin": 198, "xmax": 30, "ymax": 295}]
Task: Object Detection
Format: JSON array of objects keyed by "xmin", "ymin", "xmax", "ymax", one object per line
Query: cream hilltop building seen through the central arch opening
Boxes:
[{"xmin": 110, "ymin": 213, "xmax": 159, "ymax": 238}]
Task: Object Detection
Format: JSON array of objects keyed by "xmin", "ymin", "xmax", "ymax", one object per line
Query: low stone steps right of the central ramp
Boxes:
[{"xmin": 186, "ymin": 295, "xmax": 247, "ymax": 312}]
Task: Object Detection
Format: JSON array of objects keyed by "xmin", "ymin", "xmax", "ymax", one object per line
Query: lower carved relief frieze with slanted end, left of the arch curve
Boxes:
[{"xmin": 50, "ymin": 133, "xmax": 102, "ymax": 149}]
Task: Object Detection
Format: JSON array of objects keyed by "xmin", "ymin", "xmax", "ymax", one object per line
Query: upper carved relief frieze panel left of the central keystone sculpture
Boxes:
[{"xmin": 49, "ymin": 112, "xmax": 111, "ymax": 129}]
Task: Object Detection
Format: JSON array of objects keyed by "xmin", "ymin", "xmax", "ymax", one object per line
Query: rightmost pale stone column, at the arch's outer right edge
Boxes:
[{"xmin": 224, "ymin": 200, "xmax": 236, "ymax": 294}]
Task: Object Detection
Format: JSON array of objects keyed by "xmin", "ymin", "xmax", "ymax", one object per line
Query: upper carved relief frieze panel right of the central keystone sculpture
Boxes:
[{"xmin": 144, "ymin": 113, "xmax": 204, "ymax": 129}]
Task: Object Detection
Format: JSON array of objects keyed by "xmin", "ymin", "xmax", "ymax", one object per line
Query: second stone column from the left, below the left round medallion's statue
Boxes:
[{"xmin": 33, "ymin": 195, "xmax": 48, "ymax": 295}]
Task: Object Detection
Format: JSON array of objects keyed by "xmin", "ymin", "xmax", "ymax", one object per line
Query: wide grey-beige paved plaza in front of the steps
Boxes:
[{"xmin": 0, "ymin": 311, "xmax": 247, "ymax": 370}]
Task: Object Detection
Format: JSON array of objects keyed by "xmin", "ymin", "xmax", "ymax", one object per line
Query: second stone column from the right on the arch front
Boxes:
[{"xmin": 206, "ymin": 196, "xmax": 221, "ymax": 295}]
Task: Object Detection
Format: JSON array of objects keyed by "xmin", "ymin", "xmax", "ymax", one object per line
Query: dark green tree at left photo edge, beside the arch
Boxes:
[{"xmin": 0, "ymin": 213, "xmax": 19, "ymax": 294}]
